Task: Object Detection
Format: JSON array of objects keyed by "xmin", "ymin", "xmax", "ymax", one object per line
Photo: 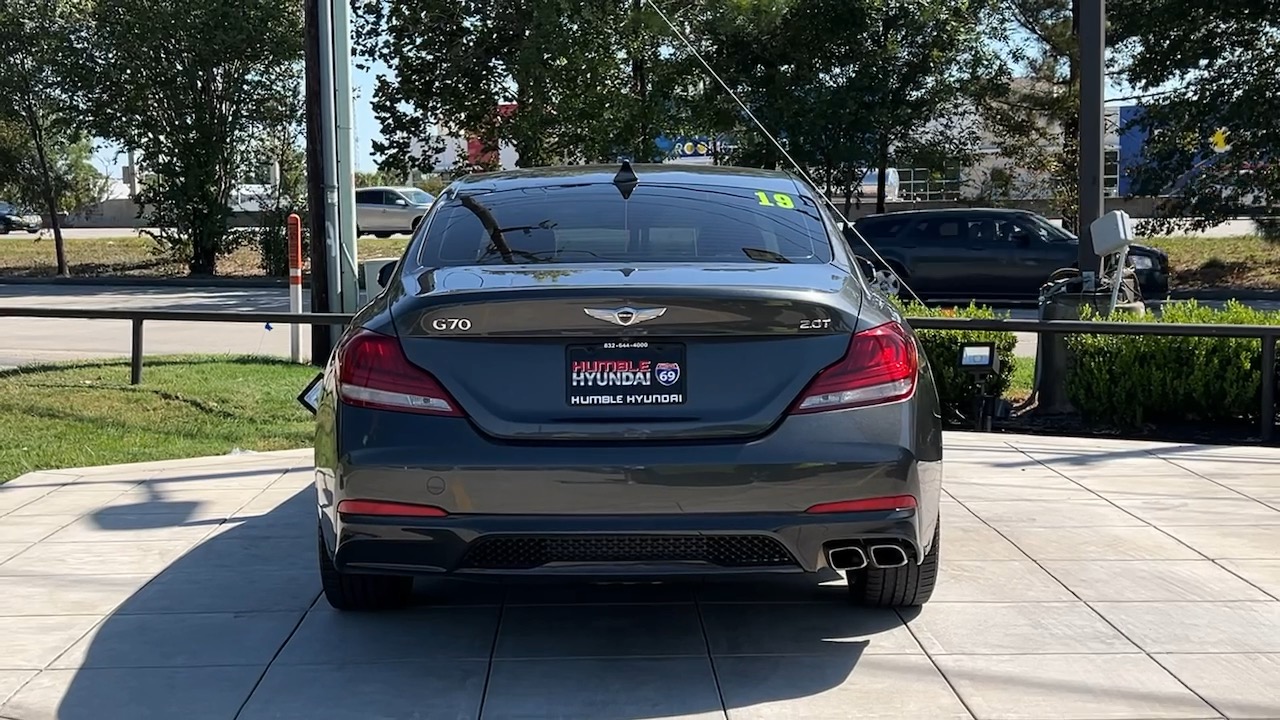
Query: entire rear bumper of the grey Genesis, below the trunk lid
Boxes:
[{"xmin": 316, "ymin": 399, "xmax": 942, "ymax": 577}]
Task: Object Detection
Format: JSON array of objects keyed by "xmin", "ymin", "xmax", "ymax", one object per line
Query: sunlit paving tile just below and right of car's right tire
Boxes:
[{"xmin": 902, "ymin": 602, "xmax": 1135, "ymax": 655}]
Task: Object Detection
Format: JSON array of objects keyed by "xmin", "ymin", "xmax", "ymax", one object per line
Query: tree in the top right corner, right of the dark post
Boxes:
[{"xmin": 1112, "ymin": 0, "xmax": 1280, "ymax": 232}]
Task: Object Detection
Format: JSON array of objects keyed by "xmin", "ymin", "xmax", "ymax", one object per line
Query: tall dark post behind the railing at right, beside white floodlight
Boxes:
[{"xmin": 1076, "ymin": 0, "xmax": 1107, "ymax": 284}]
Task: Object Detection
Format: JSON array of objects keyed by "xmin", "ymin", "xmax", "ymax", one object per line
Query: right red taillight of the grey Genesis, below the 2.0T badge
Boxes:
[{"xmin": 791, "ymin": 323, "xmax": 920, "ymax": 414}]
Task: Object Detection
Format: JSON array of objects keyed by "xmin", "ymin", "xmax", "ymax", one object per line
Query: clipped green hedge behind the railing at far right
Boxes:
[{"xmin": 1066, "ymin": 300, "xmax": 1280, "ymax": 427}]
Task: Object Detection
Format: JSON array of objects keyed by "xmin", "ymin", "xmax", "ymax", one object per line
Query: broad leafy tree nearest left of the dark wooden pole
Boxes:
[{"xmin": 78, "ymin": 0, "xmax": 302, "ymax": 274}]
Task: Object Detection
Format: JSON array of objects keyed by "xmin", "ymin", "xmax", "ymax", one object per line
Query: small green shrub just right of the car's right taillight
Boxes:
[{"xmin": 899, "ymin": 302, "xmax": 1018, "ymax": 416}]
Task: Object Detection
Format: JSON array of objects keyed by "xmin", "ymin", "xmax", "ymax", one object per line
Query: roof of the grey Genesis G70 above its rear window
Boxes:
[{"xmin": 457, "ymin": 163, "xmax": 799, "ymax": 192}]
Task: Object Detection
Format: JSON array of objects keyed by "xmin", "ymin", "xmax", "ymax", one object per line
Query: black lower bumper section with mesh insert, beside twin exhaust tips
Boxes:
[{"xmin": 334, "ymin": 510, "xmax": 932, "ymax": 577}]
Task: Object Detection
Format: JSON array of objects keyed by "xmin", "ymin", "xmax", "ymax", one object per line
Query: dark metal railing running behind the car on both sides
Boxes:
[{"xmin": 0, "ymin": 306, "xmax": 1280, "ymax": 442}]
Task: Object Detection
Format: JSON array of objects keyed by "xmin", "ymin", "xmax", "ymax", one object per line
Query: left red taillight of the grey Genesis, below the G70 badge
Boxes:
[{"xmin": 338, "ymin": 329, "xmax": 462, "ymax": 418}]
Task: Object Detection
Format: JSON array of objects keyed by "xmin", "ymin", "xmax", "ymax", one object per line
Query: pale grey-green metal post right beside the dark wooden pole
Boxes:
[{"xmin": 333, "ymin": 0, "xmax": 360, "ymax": 313}]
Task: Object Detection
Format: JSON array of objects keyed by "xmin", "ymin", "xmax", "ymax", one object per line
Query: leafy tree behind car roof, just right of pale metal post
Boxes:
[{"xmin": 355, "ymin": 0, "xmax": 696, "ymax": 174}]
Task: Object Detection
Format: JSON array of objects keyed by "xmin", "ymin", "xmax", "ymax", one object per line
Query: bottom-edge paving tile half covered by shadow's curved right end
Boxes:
[{"xmin": 716, "ymin": 655, "xmax": 970, "ymax": 720}]
